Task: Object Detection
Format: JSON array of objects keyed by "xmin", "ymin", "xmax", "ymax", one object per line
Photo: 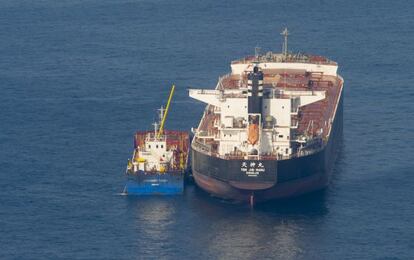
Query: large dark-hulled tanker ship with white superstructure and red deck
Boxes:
[{"xmin": 189, "ymin": 29, "xmax": 344, "ymax": 203}]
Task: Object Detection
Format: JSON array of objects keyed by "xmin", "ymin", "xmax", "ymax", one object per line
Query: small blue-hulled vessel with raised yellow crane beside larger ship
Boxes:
[{"xmin": 124, "ymin": 85, "xmax": 189, "ymax": 195}]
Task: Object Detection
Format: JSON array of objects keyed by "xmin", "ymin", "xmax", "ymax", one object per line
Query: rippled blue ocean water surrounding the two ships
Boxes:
[{"xmin": 0, "ymin": 0, "xmax": 414, "ymax": 259}]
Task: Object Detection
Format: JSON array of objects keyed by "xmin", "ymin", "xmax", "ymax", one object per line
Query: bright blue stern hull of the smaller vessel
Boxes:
[{"xmin": 124, "ymin": 172, "xmax": 184, "ymax": 195}]
